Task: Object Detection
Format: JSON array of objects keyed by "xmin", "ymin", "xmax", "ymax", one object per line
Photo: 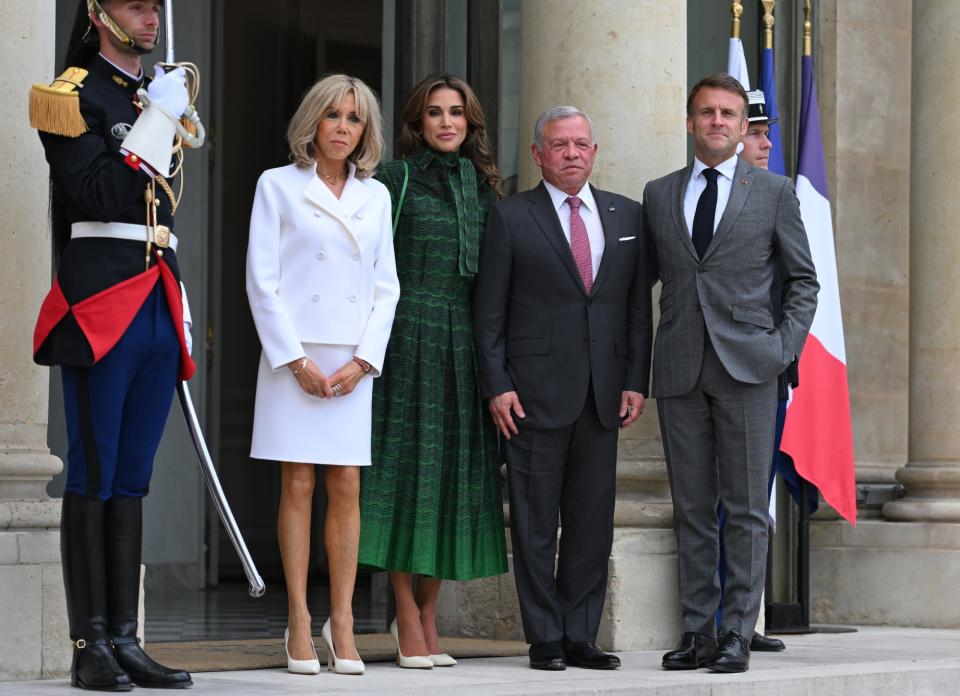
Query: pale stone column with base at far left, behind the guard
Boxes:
[{"xmin": 0, "ymin": 0, "xmax": 70, "ymax": 681}]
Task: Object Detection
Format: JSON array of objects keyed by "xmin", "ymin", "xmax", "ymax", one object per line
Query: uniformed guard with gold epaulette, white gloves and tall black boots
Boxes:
[{"xmin": 30, "ymin": 0, "xmax": 195, "ymax": 691}]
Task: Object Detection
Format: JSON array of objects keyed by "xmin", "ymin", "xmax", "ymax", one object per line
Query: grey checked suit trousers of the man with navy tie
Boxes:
[{"xmin": 657, "ymin": 341, "xmax": 777, "ymax": 639}]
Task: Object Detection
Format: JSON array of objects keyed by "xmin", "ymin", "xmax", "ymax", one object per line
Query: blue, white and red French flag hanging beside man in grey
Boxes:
[{"xmin": 780, "ymin": 55, "xmax": 857, "ymax": 525}]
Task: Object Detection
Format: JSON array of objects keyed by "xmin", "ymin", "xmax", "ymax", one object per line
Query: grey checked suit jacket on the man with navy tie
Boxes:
[{"xmin": 643, "ymin": 160, "xmax": 820, "ymax": 398}]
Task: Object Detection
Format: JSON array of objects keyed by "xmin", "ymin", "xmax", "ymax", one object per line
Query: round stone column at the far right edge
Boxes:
[{"xmin": 883, "ymin": 0, "xmax": 960, "ymax": 522}]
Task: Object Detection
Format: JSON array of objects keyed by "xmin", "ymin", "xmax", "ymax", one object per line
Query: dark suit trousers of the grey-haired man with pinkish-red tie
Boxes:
[{"xmin": 503, "ymin": 388, "xmax": 618, "ymax": 643}]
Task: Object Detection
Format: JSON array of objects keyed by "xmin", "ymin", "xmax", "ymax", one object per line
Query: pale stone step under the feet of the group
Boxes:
[{"xmin": 0, "ymin": 628, "xmax": 960, "ymax": 696}]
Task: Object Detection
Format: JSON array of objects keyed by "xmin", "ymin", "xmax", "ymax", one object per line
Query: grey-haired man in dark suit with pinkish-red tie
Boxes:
[{"xmin": 474, "ymin": 107, "xmax": 652, "ymax": 669}]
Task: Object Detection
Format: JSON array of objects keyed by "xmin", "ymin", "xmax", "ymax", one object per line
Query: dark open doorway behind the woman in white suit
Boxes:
[{"xmin": 197, "ymin": 0, "xmax": 383, "ymax": 635}]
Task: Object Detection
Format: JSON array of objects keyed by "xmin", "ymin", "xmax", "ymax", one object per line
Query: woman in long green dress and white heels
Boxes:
[{"xmin": 360, "ymin": 74, "xmax": 507, "ymax": 668}]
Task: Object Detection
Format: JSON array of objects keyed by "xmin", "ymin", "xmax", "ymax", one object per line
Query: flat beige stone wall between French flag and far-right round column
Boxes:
[{"xmin": 816, "ymin": 0, "xmax": 911, "ymax": 519}]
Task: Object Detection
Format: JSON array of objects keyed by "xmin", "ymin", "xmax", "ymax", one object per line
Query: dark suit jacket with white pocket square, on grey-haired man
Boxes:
[{"xmin": 473, "ymin": 183, "xmax": 652, "ymax": 429}]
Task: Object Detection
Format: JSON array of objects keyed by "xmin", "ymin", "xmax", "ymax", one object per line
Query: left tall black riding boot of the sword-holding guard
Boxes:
[{"xmin": 60, "ymin": 493, "xmax": 133, "ymax": 691}]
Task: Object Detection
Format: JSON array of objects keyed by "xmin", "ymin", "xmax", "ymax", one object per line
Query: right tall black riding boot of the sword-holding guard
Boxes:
[{"xmin": 106, "ymin": 498, "xmax": 193, "ymax": 689}]
